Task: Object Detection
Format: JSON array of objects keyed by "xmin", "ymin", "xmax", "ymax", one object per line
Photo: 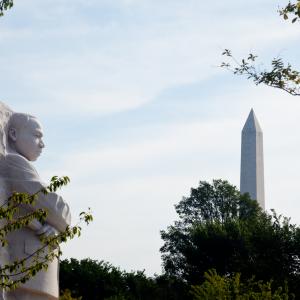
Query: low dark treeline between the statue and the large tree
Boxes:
[{"xmin": 60, "ymin": 258, "xmax": 190, "ymax": 300}]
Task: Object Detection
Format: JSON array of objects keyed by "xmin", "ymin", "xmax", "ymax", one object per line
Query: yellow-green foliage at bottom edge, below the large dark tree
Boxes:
[{"xmin": 191, "ymin": 269, "xmax": 294, "ymax": 300}]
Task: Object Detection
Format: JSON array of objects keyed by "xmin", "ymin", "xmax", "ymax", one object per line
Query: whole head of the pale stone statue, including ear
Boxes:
[{"xmin": 8, "ymin": 113, "xmax": 45, "ymax": 161}]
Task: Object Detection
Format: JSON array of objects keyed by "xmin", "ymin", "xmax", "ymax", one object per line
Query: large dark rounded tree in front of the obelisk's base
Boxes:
[{"xmin": 161, "ymin": 180, "xmax": 300, "ymax": 295}]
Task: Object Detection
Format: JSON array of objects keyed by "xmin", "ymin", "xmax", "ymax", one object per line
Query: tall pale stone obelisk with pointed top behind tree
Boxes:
[{"xmin": 240, "ymin": 109, "xmax": 265, "ymax": 209}]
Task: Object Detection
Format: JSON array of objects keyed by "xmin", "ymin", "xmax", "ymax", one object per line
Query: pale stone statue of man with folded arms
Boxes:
[{"xmin": 0, "ymin": 103, "xmax": 71, "ymax": 300}]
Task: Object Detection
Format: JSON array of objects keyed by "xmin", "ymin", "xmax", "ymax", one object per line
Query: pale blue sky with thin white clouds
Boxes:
[{"xmin": 0, "ymin": 0, "xmax": 300, "ymax": 276}]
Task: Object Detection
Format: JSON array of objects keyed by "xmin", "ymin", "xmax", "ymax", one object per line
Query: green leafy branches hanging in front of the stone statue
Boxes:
[{"xmin": 0, "ymin": 176, "xmax": 93, "ymax": 290}]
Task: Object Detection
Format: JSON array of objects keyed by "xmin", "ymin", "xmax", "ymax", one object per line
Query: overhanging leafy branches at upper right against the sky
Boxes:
[{"xmin": 221, "ymin": 0, "xmax": 300, "ymax": 96}]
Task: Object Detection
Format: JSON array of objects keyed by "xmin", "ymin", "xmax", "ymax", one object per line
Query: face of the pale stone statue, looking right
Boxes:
[{"xmin": 15, "ymin": 118, "xmax": 45, "ymax": 161}]
